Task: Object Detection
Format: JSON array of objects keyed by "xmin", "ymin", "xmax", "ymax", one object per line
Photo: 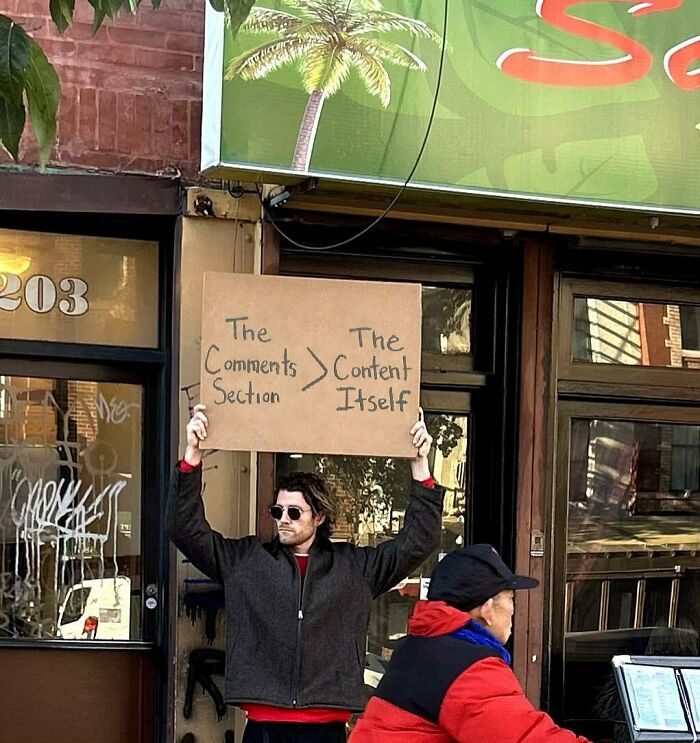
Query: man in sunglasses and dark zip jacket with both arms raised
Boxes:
[{"xmin": 169, "ymin": 405, "xmax": 444, "ymax": 743}]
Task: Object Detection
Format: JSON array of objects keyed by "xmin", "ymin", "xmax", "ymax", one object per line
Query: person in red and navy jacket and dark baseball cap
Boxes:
[{"xmin": 349, "ymin": 544, "xmax": 589, "ymax": 743}]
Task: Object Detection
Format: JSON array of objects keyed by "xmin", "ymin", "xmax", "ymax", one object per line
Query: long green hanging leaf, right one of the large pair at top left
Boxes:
[{"xmin": 26, "ymin": 41, "xmax": 61, "ymax": 165}]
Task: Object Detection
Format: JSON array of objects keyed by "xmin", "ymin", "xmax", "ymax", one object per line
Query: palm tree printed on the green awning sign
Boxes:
[{"xmin": 226, "ymin": 0, "xmax": 441, "ymax": 173}]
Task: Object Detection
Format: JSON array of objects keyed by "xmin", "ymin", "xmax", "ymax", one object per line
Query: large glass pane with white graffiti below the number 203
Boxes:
[{"xmin": 0, "ymin": 376, "xmax": 143, "ymax": 640}]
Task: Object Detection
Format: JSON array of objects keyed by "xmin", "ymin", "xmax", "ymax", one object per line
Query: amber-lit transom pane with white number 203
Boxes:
[{"xmin": 0, "ymin": 229, "xmax": 159, "ymax": 348}]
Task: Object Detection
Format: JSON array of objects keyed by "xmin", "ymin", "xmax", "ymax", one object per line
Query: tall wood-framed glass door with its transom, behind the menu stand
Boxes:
[{"xmin": 549, "ymin": 279, "xmax": 700, "ymax": 740}]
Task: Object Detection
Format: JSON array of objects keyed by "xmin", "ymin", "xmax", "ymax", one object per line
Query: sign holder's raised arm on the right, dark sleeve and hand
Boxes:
[{"xmin": 358, "ymin": 410, "xmax": 445, "ymax": 598}]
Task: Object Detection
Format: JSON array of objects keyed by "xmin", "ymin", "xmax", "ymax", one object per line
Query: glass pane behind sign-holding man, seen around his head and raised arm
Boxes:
[{"xmin": 277, "ymin": 414, "xmax": 468, "ymax": 692}]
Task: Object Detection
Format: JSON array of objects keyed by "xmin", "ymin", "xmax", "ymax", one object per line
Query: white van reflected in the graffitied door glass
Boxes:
[{"xmin": 58, "ymin": 575, "xmax": 131, "ymax": 640}]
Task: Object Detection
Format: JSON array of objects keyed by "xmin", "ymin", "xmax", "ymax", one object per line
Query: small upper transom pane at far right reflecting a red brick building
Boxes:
[{"xmin": 572, "ymin": 297, "xmax": 700, "ymax": 369}]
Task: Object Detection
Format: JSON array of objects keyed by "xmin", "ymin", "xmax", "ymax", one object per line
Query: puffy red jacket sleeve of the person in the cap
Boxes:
[{"xmin": 439, "ymin": 658, "xmax": 590, "ymax": 743}]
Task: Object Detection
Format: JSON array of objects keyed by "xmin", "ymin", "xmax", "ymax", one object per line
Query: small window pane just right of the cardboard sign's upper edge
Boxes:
[{"xmin": 422, "ymin": 286, "xmax": 472, "ymax": 355}]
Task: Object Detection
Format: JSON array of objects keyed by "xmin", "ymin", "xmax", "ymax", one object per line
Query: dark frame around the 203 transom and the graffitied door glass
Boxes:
[{"xmin": 0, "ymin": 211, "xmax": 175, "ymax": 650}]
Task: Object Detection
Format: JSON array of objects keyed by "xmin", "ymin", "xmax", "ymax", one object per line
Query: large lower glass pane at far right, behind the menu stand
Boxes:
[{"xmin": 564, "ymin": 418, "xmax": 700, "ymax": 732}]
